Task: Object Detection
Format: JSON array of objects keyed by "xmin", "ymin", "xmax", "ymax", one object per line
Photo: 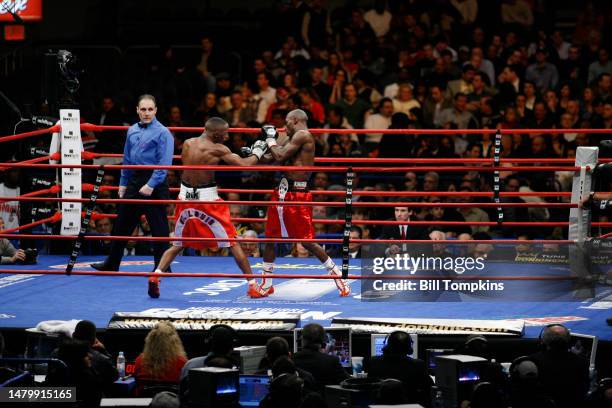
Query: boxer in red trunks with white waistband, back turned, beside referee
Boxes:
[{"xmin": 149, "ymin": 117, "xmax": 267, "ymax": 298}]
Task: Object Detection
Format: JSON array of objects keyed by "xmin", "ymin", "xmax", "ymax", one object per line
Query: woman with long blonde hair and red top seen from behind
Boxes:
[{"xmin": 134, "ymin": 322, "xmax": 187, "ymax": 393}]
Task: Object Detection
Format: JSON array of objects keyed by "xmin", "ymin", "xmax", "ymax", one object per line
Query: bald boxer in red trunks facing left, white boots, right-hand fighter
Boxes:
[{"xmin": 261, "ymin": 109, "xmax": 351, "ymax": 296}]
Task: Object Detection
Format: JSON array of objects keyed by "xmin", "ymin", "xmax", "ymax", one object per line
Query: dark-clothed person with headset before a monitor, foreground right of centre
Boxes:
[{"xmin": 365, "ymin": 331, "xmax": 433, "ymax": 406}]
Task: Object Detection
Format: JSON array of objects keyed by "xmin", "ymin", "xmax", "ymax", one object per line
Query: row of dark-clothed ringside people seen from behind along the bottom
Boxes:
[{"xmin": 0, "ymin": 321, "xmax": 612, "ymax": 408}]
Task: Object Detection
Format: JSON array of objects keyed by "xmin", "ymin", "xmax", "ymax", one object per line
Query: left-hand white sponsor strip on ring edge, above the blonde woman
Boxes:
[{"xmin": 108, "ymin": 308, "xmax": 300, "ymax": 330}]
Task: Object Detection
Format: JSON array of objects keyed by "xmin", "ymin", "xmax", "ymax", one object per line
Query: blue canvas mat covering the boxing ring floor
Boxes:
[{"xmin": 0, "ymin": 255, "xmax": 612, "ymax": 340}]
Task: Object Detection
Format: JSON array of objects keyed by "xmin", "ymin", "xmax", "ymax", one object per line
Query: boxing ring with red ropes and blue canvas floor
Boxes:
[{"xmin": 0, "ymin": 117, "xmax": 612, "ymax": 340}]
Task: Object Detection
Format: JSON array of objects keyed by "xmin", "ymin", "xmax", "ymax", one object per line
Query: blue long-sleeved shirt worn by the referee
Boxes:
[{"xmin": 119, "ymin": 118, "xmax": 174, "ymax": 188}]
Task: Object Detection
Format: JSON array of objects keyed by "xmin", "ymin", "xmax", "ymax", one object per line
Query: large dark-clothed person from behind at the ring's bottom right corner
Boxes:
[{"xmin": 530, "ymin": 324, "xmax": 589, "ymax": 408}]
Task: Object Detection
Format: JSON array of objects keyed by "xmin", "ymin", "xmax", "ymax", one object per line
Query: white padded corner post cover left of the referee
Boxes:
[{"xmin": 60, "ymin": 109, "xmax": 83, "ymax": 235}]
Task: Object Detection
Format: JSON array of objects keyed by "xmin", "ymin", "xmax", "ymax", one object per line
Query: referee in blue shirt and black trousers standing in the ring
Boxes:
[{"xmin": 91, "ymin": 94, "xmax": 174, "ymax": 271}]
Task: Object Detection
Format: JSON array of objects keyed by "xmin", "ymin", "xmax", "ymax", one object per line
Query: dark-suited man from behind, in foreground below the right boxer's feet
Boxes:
[{"xmin": 293, "ymin": 323, "xmax": 349, "ymax": 392}]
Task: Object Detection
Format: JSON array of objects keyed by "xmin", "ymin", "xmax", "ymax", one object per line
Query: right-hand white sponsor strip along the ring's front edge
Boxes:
[{"xmin": 332, "ymin": 317, "xmax": 525, "ymax": 336}]
